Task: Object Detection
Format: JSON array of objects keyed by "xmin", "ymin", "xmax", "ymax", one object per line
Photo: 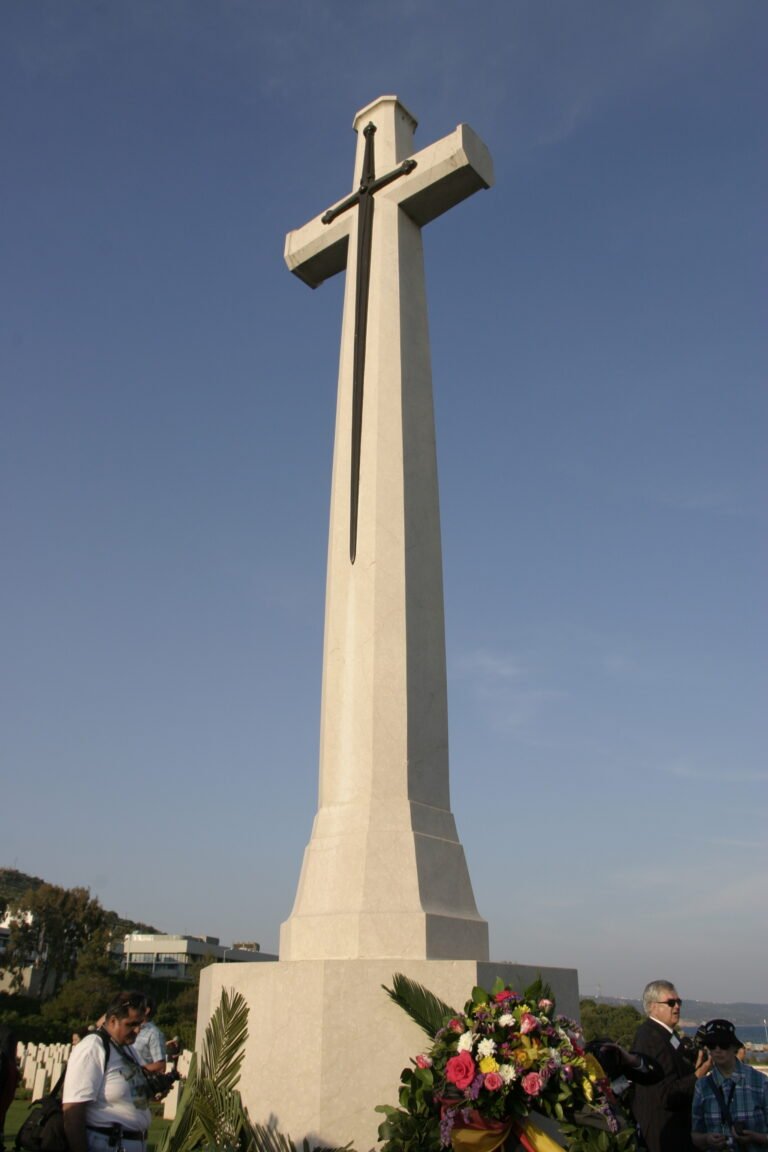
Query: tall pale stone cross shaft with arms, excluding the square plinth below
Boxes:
[{"xmin": 280, "ymin": 97, "xmax": 493, "ymax": 960}]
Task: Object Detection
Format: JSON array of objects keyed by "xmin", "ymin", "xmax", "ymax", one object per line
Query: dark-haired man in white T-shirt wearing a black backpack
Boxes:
[{"xmin": 62, "ymin": 992, "xmax": 152, "ymax": 1152}]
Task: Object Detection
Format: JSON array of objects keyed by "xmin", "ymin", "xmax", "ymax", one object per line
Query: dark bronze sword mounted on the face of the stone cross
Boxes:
[{"xmin": 321, "ymin": 123, "xmax": 416, "ymax": 564}]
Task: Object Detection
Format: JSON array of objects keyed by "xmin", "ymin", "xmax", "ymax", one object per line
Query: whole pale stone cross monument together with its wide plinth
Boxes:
[{"xmin": 198, "ymin": 97, "xmax": 578, "ymax": 1152}]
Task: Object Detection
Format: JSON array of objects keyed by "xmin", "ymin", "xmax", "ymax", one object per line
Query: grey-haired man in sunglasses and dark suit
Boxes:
[{"xmin": 632, "ymin": 980, "xmax": 712, "ymax": 1152}]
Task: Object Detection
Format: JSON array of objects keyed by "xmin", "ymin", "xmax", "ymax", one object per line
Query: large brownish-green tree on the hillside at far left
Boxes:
[{"xmin": 3, "ymin": 884, "xmax": 105, "ymax": 998}]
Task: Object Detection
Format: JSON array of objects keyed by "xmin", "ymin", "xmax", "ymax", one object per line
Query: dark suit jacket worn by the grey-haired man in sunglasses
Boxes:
[{"xmin": 632, "ymin": 1018, "xmax": 695, "ymax": 1152}]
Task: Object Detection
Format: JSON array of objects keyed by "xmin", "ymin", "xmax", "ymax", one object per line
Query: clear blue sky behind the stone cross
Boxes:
[{"xmin": 0, "ymin": 0, "xmax": 768, "ymax": 1000}]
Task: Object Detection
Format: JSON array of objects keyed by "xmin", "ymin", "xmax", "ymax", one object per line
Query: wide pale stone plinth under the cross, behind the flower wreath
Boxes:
[{"xmin": 196, "ymin": 960, "xmax": 578, "ymax": 1152}]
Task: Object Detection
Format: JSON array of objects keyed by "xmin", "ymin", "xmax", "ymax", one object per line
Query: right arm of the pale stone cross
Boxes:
[{"xmin": 381, "ymin": 124, "xmax": 494, "ymax": 227}]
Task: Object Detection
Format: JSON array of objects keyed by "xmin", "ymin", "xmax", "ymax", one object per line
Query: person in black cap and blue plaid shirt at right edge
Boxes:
[{"xmin": 691, "ymin": 1020, "xmax": 768, "ymax": 1152}]
